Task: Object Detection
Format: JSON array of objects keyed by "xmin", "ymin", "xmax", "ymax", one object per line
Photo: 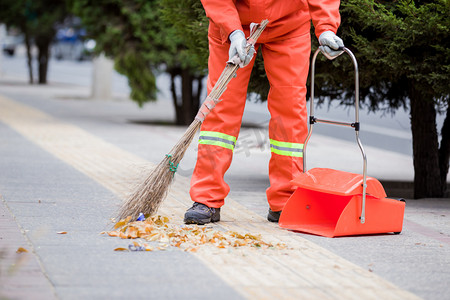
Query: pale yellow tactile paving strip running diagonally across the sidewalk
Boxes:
[{"xmin": 0, "ymin": 96, "xmax": 418, "ymax": 299}]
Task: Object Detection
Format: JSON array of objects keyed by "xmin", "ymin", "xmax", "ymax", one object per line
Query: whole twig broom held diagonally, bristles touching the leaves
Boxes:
[{"xmin": 118, "ymin": 20, "xmax": 269, "ymax": 220}]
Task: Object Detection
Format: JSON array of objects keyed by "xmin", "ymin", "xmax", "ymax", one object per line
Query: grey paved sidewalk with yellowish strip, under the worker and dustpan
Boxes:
[{"xmin": 0, "ymin": 80, "xmax": 450, "ymax": 299}]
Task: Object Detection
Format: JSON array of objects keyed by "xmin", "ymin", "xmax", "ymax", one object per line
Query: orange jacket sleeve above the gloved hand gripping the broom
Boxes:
[{"xmin": 201, "ymin": 0, "xmax": 243, "ymax": 43}]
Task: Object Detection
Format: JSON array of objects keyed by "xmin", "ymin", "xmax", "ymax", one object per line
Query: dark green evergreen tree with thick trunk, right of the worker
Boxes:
[{"xmin": 326, "ymin": 0, "xmax": 450, "ymax": 198}]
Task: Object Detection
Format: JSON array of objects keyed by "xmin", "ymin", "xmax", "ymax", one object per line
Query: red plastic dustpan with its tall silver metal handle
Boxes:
[{"xmin": 278, "ymin": 48, "xmax": 405, "ymax": 237}]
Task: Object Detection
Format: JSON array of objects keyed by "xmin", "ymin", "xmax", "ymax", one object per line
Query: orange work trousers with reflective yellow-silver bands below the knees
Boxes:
[{"xmin": 190, "ymin": 30, "xmax": 311, "ymax": 211}]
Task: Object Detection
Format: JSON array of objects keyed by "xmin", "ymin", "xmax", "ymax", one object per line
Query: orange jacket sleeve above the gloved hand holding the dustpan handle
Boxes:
[{"xmin": 308, "ymin": 0, "xmax": 341, "ymax": 38}]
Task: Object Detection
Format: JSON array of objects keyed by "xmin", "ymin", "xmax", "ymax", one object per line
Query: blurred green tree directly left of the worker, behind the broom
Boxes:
[{"xmin": 68, "ymin": 0, "xmax": 203, "ymax": 125}]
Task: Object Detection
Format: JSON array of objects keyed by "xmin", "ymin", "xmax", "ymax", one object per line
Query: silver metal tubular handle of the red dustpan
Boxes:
[{"xmin": 303, "ymin": 47, "xmax": 367, "ymax": 224}]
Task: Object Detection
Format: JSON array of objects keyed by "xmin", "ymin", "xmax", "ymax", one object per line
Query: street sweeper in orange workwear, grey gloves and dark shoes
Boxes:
[{"xmin": 184, "ymin": 0, "xmax": 344, "ymax": 224}]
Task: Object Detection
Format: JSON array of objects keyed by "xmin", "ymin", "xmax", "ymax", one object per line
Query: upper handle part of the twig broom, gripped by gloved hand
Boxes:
[{"xmin": 195, "ymin": 20, "xmax": 269, "ymax": 123}]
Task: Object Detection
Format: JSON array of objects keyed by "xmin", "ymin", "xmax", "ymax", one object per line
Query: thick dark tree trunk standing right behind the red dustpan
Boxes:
[{"xmin": 409, "ymin": 82, "xmax": 443, "ymax": 199}]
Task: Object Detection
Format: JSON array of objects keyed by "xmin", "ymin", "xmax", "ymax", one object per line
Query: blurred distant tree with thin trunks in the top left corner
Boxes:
[{"xmin": 0, "ymin": 0, "xmax": 68, "ymax": 84}]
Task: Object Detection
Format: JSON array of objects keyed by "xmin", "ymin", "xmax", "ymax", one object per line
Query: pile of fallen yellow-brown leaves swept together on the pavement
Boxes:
[{"xmin": 102, "ymin": 216, "xmax": 287, "ymax": 252}]
